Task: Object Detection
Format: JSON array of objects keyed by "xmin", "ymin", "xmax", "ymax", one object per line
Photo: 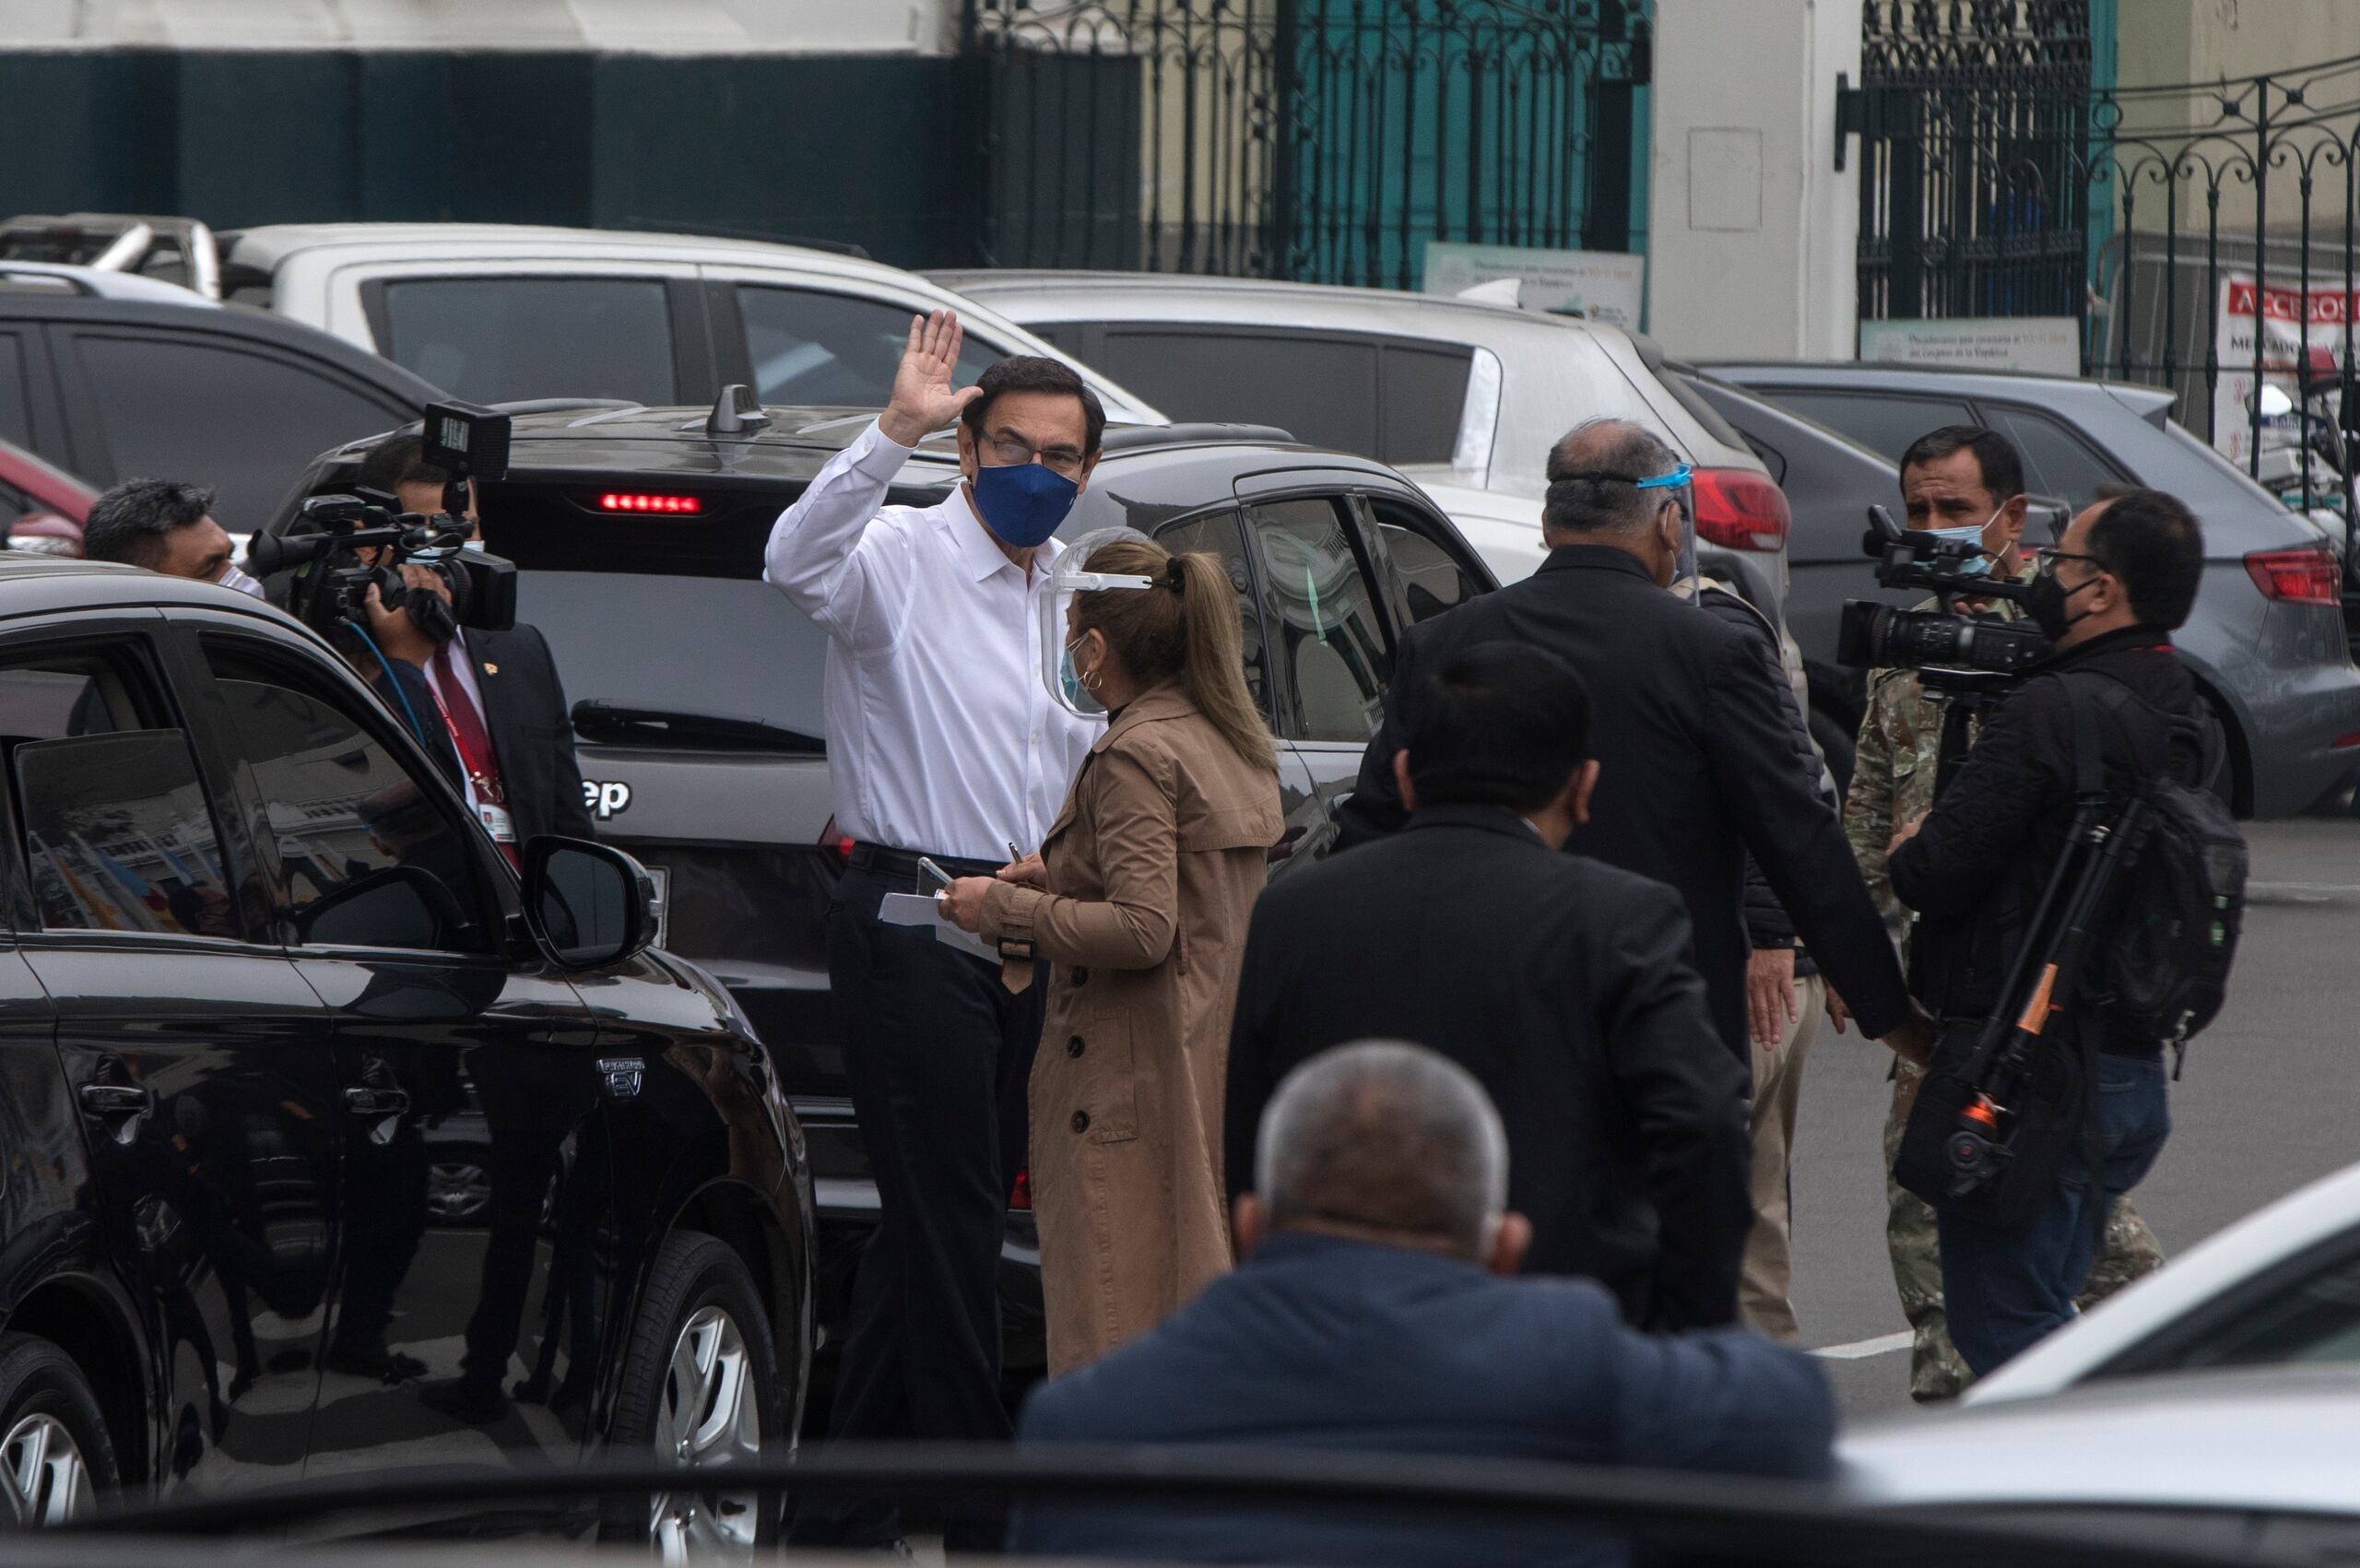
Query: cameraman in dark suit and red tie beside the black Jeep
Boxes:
[{"xmin": 354, "ymin": 434, "xmax": 597, "ymax": 862}]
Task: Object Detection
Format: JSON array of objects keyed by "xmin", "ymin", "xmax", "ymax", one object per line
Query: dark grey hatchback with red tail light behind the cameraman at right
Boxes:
[{"xmin": 1702, "ymin": 364, "xmax": 2360, "ymax": 817}]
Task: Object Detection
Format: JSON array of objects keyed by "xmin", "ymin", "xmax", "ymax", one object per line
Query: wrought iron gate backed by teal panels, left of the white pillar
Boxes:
[{"xmin": 965, "ymin": 0, "xmax": 1649, "ymax": 289}]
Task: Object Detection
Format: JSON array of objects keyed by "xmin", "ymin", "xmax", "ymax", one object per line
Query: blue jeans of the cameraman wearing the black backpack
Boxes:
[{"xmin": 1940, "ymin": 1054, "xmax": 2171, "ymax": 1376}]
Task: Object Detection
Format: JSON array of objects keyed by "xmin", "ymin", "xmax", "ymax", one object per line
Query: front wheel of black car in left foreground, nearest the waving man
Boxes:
[{"xmin": 599, "ymin": 1231, "xmax": 793, "ymax": 1563}]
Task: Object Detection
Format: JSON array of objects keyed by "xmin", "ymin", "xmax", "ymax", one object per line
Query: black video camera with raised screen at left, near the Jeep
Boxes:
[{"xmin": 245, "ymin": 401, "xmax": 517, "ymax": 643}]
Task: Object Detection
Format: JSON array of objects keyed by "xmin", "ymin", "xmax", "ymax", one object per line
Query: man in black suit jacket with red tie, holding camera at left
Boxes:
[{"xmin": 354, "ymin": 434, "xmax": 597, "ymax": 848}]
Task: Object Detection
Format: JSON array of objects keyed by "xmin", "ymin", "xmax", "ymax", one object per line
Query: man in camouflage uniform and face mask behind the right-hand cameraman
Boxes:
[{"xmin": 1832, "ymin": 425, "xmax": 2165, "ymax": 1400}]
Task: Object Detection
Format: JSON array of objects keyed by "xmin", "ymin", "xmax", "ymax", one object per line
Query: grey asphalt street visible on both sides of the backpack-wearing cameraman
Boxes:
[{"xmin": 1794, "ymin": 817, "xmax": 2360, "ymax": 1421}]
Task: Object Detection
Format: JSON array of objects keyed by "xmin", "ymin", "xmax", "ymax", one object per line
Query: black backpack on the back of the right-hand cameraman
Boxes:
[{"xmin": 2074, "ymin": 680, "xmax": 2247, "ymax": 1046}]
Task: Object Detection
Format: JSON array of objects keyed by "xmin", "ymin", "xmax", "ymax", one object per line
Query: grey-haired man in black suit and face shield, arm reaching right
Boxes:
[{"xmin": 1340, "ymin": 420, "xmax": 1933, "ymax": 1063}]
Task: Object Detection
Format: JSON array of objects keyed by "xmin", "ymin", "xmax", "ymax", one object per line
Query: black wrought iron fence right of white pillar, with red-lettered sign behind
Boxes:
[{"xmin": 1838, "ymin": 0, "xmax": 2360, "ymax": 508}]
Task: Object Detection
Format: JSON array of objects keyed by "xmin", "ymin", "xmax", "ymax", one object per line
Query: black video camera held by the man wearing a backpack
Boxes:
[{"xmin": 1836, "ymin": 505, "xmax": 2048, "ymax": 676}]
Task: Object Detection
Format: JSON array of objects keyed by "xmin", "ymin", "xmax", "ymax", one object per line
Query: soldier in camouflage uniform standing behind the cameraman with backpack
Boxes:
[{"xmin": 1843, "ymin": 430, "xmax": 2165, "ymax": 1400}]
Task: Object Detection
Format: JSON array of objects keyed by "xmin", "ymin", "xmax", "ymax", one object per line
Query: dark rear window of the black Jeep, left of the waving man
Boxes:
[{"xmin": 517, "ymin": 572, "xmax": 829, "ymax": 739}]
